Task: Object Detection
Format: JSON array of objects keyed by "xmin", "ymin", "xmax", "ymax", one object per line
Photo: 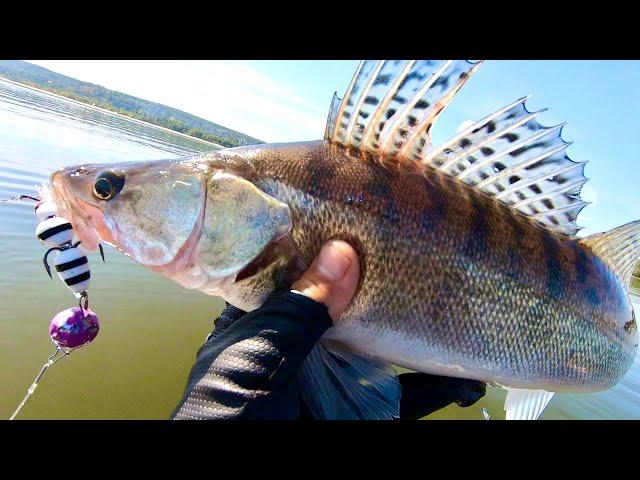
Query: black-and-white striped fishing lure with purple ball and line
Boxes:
[{"xmin": 2, "ymin": 195, "xmax": 104, "ymax": 420}]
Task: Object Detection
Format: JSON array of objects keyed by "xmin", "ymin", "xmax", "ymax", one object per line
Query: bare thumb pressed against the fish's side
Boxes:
[{"xmin": 291, "ymin": 240, "xmax": 360, "ymax": 322}]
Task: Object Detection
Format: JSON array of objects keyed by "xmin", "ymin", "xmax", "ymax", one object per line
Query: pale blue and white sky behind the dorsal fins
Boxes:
[{"xmin": 32, "ymin": 60, "xmax": 640, "ymax": 235}]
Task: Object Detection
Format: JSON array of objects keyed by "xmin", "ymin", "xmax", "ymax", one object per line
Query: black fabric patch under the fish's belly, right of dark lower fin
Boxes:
[{"xmin": 398, "ymin": 373, "xmax": 486, "ymax": 419}]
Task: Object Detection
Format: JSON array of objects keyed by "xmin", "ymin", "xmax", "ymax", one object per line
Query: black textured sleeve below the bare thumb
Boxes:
[{"xmin": 172, "ymin": 292, "xmax": 332, "ymax": 420}]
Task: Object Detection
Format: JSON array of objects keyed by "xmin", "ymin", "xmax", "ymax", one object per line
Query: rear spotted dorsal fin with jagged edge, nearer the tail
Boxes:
[{"xmin": 422, "ymin": 97, "xmax": 587, "ymax": 235}]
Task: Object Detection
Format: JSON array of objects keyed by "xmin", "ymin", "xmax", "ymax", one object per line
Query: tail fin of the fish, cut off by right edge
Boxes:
[{"xmin": 580, "ymin": 220, "xmax": 640, "ymax": 291}]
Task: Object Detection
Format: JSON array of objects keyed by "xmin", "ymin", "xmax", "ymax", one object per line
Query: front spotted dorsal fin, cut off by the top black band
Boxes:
[{"xmin": 325, "ymin": 60, "xmax": 479, "ymax": 157}]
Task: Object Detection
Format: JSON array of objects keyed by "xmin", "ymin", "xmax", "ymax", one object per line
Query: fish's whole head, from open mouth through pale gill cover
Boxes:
[{"xmin": 49, "ymin": 154, "xmax": 291, "ymax": 297}]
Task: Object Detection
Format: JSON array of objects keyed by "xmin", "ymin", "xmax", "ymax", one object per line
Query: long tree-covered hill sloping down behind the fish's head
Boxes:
[{"xmin": 0, "ymin": 60, "xmax": 264, "ymax": 147}]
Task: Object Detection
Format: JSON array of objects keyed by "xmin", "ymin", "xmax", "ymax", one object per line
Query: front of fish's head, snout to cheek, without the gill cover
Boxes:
[{"xmin": 50, "ymin": 160, "xmax": 206, "ymax": 266}]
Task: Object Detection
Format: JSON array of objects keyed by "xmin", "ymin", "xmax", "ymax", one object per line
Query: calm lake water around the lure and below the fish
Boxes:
[{"xmin": 0, "ymin": 81, "xmax": 640, "ymax": 419}]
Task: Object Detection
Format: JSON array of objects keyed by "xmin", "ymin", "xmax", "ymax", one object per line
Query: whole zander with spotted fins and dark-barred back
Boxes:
[{"xmin": 46, "ymin": 60, "xmax": 640, "ymax": 419}]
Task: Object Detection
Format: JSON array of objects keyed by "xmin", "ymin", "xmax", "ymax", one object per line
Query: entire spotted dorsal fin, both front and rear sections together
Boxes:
[{"xmin": 325, "ymin": 60, "xmax": 587, "ymax": 235}]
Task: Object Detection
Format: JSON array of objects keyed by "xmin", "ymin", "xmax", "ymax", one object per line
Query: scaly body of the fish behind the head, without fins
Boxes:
[{"xmin": 227, "ymin": 142, "xmax": 634, "ymax": 391}]
